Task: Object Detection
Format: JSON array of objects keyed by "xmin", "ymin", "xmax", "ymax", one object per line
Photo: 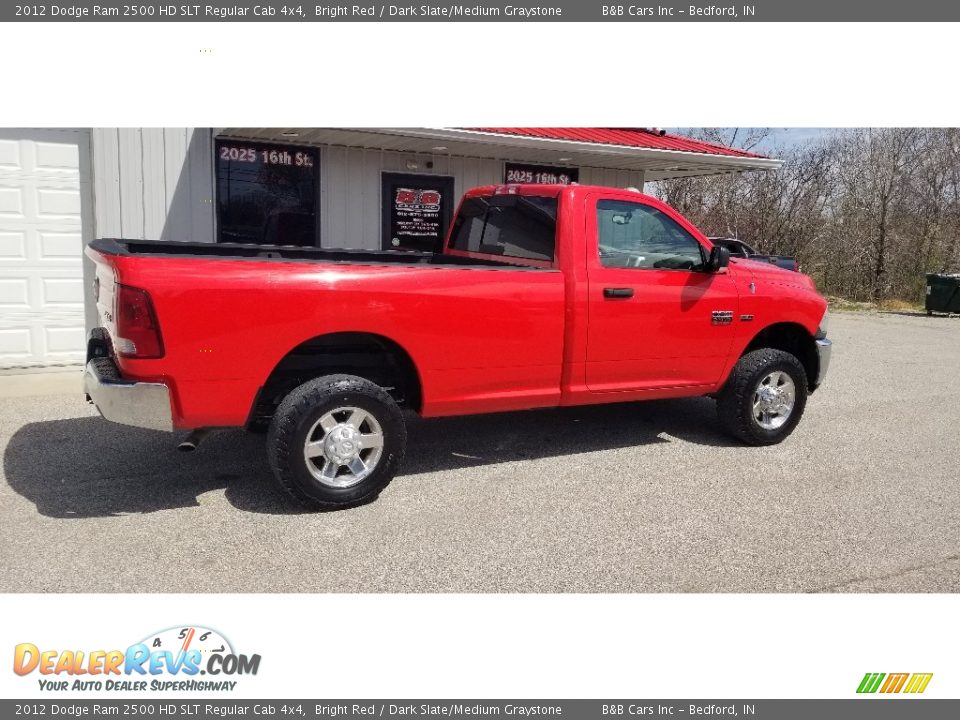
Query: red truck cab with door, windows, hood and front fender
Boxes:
[{"xmin": 444, "ymin": 185, "xmax": 826, "ymax": 404}]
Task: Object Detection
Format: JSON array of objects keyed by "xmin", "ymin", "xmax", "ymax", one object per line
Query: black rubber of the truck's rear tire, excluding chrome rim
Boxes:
[{"xmin": 267, "ymin": 375, "xmax": 407, "ymax": 509}]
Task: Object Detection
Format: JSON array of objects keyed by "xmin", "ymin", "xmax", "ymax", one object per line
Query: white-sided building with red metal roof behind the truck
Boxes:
[{"xmin": 0, "ymin": 128, "xmax": 780, "ymax": 369}]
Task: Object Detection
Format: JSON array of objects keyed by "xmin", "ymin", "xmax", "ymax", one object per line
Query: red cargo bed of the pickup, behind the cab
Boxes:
[{"xmin": 87, "ymin": 239, "xmax": 566, "ymax": 429}]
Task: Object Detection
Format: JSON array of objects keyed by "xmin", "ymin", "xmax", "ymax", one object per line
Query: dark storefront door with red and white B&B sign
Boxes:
[{"xmin": 380, "ymin": 173, "xmax": 455, "ymax": 252}]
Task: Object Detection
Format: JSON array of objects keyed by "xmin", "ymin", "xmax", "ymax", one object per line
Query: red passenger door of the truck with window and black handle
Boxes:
[{"xmin": 585, "ymin": 194, "xmax": 739, "ymax": 392}]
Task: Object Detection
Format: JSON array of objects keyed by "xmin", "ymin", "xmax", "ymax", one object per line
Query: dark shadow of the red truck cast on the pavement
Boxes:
[{"xmin": 3, "ymin": 398, "xmax": 736, "ymax": 518}]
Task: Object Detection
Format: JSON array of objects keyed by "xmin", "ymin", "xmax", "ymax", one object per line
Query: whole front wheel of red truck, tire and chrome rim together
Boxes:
[{"xmin": 717, "ymin": 348, "xmax": 808, "ymax": 445}]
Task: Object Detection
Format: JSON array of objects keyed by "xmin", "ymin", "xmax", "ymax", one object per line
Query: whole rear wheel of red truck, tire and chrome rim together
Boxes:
[{"xmin": 267, "ymin": 375, "xmax": 407, "ymax": 509}]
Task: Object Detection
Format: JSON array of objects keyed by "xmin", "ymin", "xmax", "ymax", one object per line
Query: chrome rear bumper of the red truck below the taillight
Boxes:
[{"xmin": 83, "ymin": 357, "xmax": 173, "ymax": 431}]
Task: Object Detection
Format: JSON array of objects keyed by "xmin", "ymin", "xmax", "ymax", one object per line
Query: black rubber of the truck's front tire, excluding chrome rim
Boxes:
[{"xmin": 717, "ymin": 348, "xmax": 808, "ymax": 445}]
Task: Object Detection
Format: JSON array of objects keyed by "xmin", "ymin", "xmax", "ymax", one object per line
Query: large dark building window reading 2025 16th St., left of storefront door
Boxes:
[{"xmin": 216, "ymin": 140, "xmax": 320, "ymax": 246}]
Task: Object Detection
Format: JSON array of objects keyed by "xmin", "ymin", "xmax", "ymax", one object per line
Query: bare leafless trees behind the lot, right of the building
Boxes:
[{"xmin": 654, "ymin": 128, "xmax": 960, "ymax": 302}]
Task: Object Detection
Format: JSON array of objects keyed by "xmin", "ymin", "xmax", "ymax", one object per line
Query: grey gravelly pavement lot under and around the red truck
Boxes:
[{"xmin": 0, "ymin": 314, "xmax": 960, "ymax": 592}]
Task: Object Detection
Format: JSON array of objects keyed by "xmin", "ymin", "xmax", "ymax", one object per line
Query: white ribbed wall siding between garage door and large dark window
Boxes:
[{"xmin": 91, "ymin": 128, "xmax": 214, "ymax": 242}]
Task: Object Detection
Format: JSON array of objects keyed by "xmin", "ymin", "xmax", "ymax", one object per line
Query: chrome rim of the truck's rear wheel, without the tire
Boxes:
[{"xmin": 303, "ymin": 407, "xmax": 383, "ymax": 488}]
